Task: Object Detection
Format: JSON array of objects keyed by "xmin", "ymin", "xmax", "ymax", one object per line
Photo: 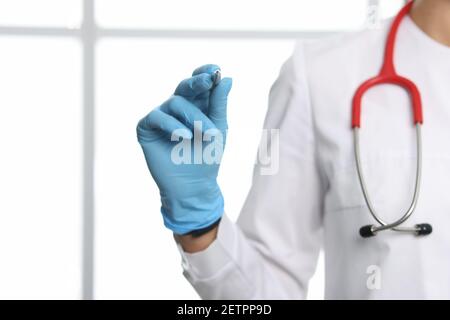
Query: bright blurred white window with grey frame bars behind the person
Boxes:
[{"xmin": 0, "ymin": 0, "xmax": 404, "ymax": 299}]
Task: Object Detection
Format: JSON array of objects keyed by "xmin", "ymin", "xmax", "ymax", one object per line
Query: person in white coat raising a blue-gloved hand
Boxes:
[{"xmin": 137, "ymin": 0, "xmax": 450, "ymax": 299}]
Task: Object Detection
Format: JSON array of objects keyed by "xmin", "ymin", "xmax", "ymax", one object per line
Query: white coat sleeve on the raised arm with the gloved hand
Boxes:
[{"xmin": 180, "ymin": 43, "xmax": 324, "ymax": 299}]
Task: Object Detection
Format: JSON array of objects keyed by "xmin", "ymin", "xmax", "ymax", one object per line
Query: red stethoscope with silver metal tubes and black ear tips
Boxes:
[{"xmin": 352, "ymin": 1, "xmax": 433, "ymax": 238}]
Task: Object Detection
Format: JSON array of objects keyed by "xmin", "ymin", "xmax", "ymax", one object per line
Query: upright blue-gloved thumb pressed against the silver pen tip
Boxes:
[{"xmin": 208, "ymin": 78, "xmax": 233, "ymax": 130}]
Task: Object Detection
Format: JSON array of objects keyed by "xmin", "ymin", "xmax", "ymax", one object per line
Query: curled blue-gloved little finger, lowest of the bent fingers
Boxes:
[{"xmin": 138, "ymin": 108, "xmax": 192, "ymax": 139}]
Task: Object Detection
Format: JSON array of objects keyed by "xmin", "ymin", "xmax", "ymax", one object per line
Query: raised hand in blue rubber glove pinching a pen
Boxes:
[{"xmin": 137, "ymin": 65, "xmax": 232, "ymax": 234}]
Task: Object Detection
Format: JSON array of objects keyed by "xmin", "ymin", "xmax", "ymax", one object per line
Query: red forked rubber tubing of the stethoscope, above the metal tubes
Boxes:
[{"xmin": 352, "ymin": 1, "xmax": 423, "ymax": 128}]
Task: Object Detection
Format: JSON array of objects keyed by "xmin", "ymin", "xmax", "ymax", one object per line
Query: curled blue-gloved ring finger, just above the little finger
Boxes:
[{"xmin": 161, "ymin": 96, "xmax": 216, "ymax": 132}]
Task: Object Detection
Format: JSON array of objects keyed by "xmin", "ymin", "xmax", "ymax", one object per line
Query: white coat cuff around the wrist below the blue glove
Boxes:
[{"xmin": 178, "ymin": 215, "xmax": 236, "ymax": 280}]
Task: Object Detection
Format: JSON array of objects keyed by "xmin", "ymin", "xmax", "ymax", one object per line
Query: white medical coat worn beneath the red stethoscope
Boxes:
[{"xmin": 175, "ymin": 17, "xmax": 450, "ymax": 299}]
